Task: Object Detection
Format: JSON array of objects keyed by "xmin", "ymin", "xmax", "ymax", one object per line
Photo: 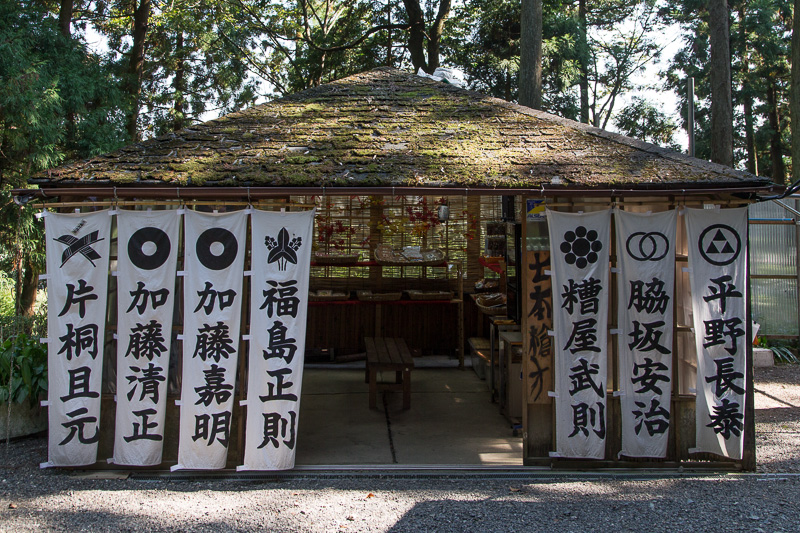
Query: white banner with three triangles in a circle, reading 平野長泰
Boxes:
[{"xmin": 686, "ymin": 207, "xmax": 748, "ymax": 459}]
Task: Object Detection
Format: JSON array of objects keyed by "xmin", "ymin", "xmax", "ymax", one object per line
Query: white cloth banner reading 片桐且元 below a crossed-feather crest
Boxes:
[{"xmin": 45, "ymin": 210, "xmax": 111, "ymax": 466}]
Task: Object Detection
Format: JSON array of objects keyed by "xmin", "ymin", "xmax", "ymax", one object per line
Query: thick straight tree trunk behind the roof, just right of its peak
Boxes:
[{"xmin": 519, "ymin": 0, "xmax": 542, "ymax": 109}]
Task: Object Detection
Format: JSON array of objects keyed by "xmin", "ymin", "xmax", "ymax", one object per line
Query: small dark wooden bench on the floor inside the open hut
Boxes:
[{"xmin": 364, "ymin": 337, "xmax": 414, "ymax": 409}]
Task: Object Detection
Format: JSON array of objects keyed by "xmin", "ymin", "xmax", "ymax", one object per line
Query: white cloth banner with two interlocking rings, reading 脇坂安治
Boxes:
[{"xmin": 615, "ymin": 210, "xmax": 678, "ymax": 457}]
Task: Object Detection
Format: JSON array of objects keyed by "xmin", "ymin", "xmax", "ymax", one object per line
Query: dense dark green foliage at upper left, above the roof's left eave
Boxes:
[{"xmin": 0, "ymin": 0, "xmax": 124, "ymax": 188}]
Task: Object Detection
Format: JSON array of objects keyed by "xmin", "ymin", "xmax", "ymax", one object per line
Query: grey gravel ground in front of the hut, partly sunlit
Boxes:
[{"xmin": 0, "ymin": 366, "xmax": 800, "ymax": 532}]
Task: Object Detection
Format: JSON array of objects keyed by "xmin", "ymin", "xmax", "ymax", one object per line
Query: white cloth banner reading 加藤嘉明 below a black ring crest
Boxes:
[{"xmin": 173, "ymin": 211, "xmax": 247, "ymax": 470}]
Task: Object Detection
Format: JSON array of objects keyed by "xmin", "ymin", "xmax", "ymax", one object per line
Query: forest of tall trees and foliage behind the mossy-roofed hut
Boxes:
[{"xmin": 0, "ymin": 0, "xmax": 800, "ymax": 316}]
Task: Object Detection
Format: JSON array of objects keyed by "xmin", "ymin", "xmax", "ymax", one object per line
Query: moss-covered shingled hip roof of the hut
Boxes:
[{"xmin": 31, "ymin": 68, "xmax": 769, "ymax": 188}]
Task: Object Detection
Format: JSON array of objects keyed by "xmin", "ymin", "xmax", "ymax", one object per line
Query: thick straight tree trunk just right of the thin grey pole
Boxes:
[{"xmin": 708, "ymin": 0, "xmax": 733, "ymax": 167}]
